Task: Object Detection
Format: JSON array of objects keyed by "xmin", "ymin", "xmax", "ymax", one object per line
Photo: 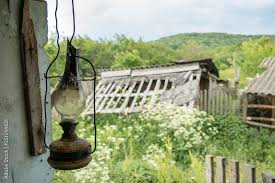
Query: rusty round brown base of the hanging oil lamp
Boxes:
[{"xmin": 48, "ymin": 120, "xmax": 92, "ymax": 170}]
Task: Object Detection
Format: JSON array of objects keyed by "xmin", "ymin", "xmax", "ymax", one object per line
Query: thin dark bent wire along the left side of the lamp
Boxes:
[{"xmin": 44, "ymin": 0, "xmax": 60, "ymax": 149}]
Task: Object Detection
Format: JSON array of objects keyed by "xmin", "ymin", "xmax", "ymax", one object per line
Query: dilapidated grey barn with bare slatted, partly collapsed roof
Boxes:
[{"xmin": 84, "ymin": 59, "xmax": 230, "ymax": 114}]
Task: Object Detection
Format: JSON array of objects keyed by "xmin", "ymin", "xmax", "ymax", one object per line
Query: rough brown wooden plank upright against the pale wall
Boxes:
[{"xmin": 21, "ymin": 0, "xmax": 46, "ymax": 156}]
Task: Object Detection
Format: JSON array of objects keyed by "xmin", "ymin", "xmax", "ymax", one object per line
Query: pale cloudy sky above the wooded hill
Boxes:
[{"xmin": 47, "ymin": 0, "xmax": 275, "ymax": 40}]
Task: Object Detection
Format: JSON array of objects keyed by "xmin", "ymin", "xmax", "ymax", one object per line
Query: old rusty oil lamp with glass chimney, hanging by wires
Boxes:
[{"xmin": 45, "ymin": 41, "xmax": 96, "ymax": 170}]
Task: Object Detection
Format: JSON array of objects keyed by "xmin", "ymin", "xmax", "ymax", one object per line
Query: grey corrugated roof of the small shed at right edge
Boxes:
[{"xmin": 246, "ymin": 57, "xmax": 275, "ymax": 95}]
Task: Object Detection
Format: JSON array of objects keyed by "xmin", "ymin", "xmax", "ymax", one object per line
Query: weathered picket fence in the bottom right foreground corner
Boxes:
[{"xmin": 205, "ymin": 155, "xmax": 275, "ymax": 183}]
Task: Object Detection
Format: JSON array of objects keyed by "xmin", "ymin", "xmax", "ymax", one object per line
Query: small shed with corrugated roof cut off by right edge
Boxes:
[{"xmin": 242, "ymin": 57, "xmax": 275, "ymax": 129}]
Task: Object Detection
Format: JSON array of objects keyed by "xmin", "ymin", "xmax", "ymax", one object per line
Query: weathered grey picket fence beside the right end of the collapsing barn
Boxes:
[{"xmin": 198, "ymin": 88, "xmax": 240, "ymax": 114}]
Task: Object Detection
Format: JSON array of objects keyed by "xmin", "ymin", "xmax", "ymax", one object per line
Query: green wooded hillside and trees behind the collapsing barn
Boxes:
[{"xmin": 45, "ymin": 33, "xmax": 275, "ymax": 87}]
